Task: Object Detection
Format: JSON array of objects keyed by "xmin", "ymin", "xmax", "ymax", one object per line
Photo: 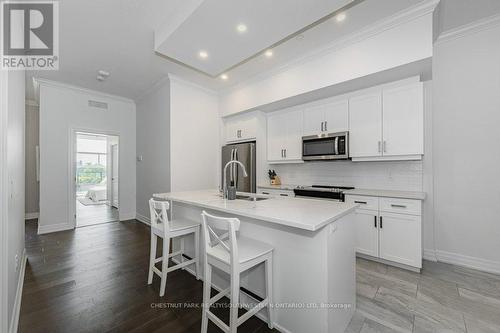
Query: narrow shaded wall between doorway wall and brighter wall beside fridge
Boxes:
[{"xmin": 136, "ymin": 80, "xmax": 170, "ymax": 220}]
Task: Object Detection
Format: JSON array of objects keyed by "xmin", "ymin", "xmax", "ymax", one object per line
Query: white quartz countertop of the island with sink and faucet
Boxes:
[{"xmin": 153, "ymin": 190, "xmax": 358, "ymax": 231}]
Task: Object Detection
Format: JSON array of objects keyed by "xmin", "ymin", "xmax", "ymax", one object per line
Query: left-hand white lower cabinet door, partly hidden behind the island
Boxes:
[{"xmin": 354, "ymin": 209, "xmax": 378, "ymax": 257}]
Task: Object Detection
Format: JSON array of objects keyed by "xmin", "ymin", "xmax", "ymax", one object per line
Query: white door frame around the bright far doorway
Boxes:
[{"xmin": 68, "ymin": 127, "xmax": 121, "ymax": 229}]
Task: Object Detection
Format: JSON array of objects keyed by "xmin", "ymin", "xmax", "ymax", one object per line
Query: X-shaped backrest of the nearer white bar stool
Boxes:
[{"xmin": 201, "ymin": 211, "xmax": 240, "ymax": 267}]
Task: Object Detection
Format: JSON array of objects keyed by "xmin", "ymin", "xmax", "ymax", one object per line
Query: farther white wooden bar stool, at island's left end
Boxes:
[{"xmin": 148, "ymin": 199, "xmax": 200, "ymax": 296}]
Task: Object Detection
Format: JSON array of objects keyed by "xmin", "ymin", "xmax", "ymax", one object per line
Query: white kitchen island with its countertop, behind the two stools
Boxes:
[{"xmin": 154, "ymin": 190, "xmax": 357, "ymax": 333}]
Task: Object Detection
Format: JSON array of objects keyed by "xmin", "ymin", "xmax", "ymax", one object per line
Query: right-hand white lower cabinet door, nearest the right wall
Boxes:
[{"xmin": 379, "ymin": 212, "xmax": 422, "ymax": 268}]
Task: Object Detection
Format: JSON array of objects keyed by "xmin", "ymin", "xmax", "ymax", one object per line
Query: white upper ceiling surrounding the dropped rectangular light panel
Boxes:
[{"xmin": 27, "ymin": 0, "xmax": 424, "ymax": 99}]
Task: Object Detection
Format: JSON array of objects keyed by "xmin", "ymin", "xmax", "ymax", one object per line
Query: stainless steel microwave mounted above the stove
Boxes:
[{"xmin": 302, "ymin": 132, "xmax": 349, "ymax": 161}]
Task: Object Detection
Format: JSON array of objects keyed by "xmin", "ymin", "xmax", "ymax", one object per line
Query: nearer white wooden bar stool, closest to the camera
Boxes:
[{"xmin": 201, "ymin": 211, "xmax": 274, "ymax": 333}]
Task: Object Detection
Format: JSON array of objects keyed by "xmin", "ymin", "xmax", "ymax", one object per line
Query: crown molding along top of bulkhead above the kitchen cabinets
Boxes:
[{"xmin": 220, "ymin": 0, "xmax": 440, "ymax": 94}]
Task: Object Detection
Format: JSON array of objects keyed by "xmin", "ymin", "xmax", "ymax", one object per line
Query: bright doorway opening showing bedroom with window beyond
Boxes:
[{"xmin": 74, "ymin": 132, "xmax": 120, "ymax": 228}]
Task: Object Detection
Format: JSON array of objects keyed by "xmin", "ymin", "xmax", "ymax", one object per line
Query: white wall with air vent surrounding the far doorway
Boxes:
[{"xmin": 39, "ymin": 81, "xmax": 136, "ymax": 233}]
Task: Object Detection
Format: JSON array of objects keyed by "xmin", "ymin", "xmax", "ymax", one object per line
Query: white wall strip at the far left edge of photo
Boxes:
[{"xmin": 0, "ymin": 71, "xmax": 25, "ymax": 332}]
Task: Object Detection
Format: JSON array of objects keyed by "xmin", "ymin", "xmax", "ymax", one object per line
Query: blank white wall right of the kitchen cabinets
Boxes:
[{"xmin": 433, "ymin": 24, "xmax": 500, "ymax": 272}]
